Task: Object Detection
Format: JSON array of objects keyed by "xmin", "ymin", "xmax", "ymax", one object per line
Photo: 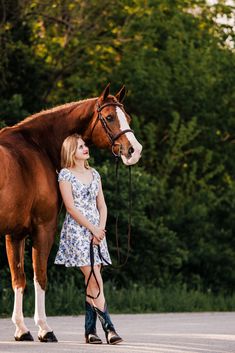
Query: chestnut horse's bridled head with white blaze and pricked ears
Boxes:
[{"xmin": 87, "ymin": 84, "xmax": 142, "ymax": 165}]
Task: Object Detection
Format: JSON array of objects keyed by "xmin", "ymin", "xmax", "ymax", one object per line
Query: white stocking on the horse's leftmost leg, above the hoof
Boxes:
[{"xmin": 12, "ymin": 288, "xmax": 29, "ymax": 337}]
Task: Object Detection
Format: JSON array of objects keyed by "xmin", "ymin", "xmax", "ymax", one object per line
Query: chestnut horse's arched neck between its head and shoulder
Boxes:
[{"xmin": 18, "ymin": 99, "xmax": 96, "ymax": 169}]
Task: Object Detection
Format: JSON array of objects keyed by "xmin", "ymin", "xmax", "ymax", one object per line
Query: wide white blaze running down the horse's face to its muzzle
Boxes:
[{"xmin": 116, "ymin": 107, "xmax": 142, "ymax": 165}]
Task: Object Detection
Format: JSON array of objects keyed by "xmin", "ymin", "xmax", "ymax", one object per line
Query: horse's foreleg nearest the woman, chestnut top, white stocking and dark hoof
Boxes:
[{"xmin": 32, "ymin": 226, "xmax": 57, "ymax": 342}]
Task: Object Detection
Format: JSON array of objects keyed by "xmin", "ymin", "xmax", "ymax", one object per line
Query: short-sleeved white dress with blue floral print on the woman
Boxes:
[{"xmin": 55, "ymin": 168, "xmax": 111, "ymax": 267}]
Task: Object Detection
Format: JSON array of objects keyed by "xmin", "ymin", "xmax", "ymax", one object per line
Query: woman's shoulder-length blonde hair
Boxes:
[{"xmin": 61, "ymin": 134, "xmax": 89, "ymax": 169}]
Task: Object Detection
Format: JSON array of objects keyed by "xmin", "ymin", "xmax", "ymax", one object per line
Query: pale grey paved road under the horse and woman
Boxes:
[{"xmin": 0, "ymin": 312, "xmax": 235, "ymax": 353}]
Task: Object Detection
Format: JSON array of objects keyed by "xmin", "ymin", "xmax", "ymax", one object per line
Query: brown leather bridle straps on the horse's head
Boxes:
[{"xmin": 91, "ymin": 102, "xmax": 134, "ymax": 157}]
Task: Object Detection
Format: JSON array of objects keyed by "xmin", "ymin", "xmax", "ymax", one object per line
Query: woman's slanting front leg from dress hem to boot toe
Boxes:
[{"xmin": 82, "ymin": 266, "xmax": 122, "ymax": 344}]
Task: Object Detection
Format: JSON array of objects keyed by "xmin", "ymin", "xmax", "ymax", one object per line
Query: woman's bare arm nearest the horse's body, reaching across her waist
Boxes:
[{"xmin": 59, "ymin": 181, "xmax": 104, "ymax": 240}]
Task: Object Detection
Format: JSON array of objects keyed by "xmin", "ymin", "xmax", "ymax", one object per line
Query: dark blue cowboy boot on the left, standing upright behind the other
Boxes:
[{"xmin": 85, "ymin": 301, "xmax": 102, "ymax": 344}]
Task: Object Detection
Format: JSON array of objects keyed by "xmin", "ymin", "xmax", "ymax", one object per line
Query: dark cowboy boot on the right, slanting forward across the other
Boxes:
[{"xmin": 95, "ymin": 304, "xmax": 122, "ymax": 344}]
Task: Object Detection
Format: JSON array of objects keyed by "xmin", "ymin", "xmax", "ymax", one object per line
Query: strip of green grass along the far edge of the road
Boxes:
[{"xmin": 0, "ymin": 277, "xmax": 235, "ymax": 317}]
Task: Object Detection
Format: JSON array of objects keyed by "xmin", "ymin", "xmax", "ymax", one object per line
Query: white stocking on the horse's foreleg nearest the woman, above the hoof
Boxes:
[{"xmin": 34, "ymin": 277, "xmax": 52, "ymax": 337}]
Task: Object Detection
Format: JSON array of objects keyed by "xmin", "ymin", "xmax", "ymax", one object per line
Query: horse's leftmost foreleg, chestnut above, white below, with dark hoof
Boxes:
[{"xmin": 6, "ymin": 235, "xmax": 33, "ymax": 341}]
